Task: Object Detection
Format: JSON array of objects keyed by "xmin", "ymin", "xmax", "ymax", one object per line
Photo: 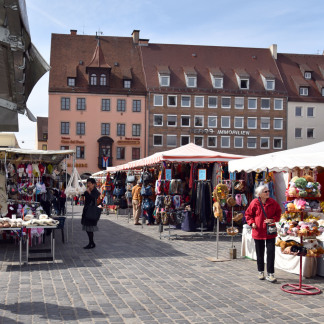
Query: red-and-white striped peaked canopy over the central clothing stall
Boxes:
[{"xmin": 117, "ymin": 143, "xmax": 245, "ymax": 170}]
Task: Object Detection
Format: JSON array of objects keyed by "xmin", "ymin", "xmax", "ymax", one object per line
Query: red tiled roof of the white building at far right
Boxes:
[{"xmin": 277, "ymin": 53, "xmax": 324, "ymax": 102}]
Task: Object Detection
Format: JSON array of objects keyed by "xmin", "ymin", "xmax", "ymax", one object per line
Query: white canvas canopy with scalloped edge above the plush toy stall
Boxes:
[{"xmin": 228, "ymin": 142, "xmax": 324, "ymax": 172}]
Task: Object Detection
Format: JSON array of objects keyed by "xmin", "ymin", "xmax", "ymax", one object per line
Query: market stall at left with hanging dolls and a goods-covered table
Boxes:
[{"xmin": 0, "ymin": 148, "xmax": 74, "ymax": 263}]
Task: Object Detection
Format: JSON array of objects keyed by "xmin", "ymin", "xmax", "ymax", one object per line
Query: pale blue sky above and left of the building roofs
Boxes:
[{"xmin": 15, "ymin": 0, "xmax": 324, "ymax": 149}]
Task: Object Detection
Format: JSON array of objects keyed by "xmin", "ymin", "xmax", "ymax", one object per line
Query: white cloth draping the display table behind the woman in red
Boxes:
[{"xmin": 241, "ymin": 225, "xmax": 324, "ymax": 278}]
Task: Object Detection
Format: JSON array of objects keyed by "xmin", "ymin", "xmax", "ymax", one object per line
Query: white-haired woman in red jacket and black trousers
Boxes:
[{"xmin": 245, "ymin": 185, "xmax": 281, "ymax": 282}]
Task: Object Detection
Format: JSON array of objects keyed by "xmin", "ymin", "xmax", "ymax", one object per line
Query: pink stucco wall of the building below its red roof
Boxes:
[{"xmin": 48, "ymin": 93, "xmax": 146, "ymax": 174}]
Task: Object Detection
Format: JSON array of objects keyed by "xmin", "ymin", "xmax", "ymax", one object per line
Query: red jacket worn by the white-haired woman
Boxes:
[{"xmin": 245, "ymin": 198, "xmax": 282, "ymax": 240}]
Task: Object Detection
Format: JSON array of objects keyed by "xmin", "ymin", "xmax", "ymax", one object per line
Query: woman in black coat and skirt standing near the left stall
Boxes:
[{"xmin": 81, "ymin": 178, "xmax": 100, "ymax": 249}]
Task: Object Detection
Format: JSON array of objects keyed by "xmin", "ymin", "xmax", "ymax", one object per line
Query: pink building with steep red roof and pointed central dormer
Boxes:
[{"xmin": 48, "ymin": 31, "xmax": 147, "ymax": 174}]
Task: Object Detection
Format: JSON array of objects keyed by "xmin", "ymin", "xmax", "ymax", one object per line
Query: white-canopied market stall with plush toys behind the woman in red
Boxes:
[{"xmin": 229, "ymin": 142, "xmax": 324, "ymax": 293}]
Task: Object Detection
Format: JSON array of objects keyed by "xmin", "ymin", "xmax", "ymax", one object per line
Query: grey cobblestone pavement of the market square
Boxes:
[{"xmin": 0, "ymin": 206, "xmax": 324, "ymax": 324}]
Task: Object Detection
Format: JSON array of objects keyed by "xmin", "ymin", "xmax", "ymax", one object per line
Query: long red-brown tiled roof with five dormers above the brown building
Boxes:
[{"xmin": 141, "ymin": 43, "xmax": 286, "ymax": 95}]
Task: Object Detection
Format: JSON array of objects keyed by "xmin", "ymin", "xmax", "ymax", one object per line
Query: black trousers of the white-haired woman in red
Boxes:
[{"xmin": 254, "ymin": 238, "xmax": 276, "ymax": 273}]
